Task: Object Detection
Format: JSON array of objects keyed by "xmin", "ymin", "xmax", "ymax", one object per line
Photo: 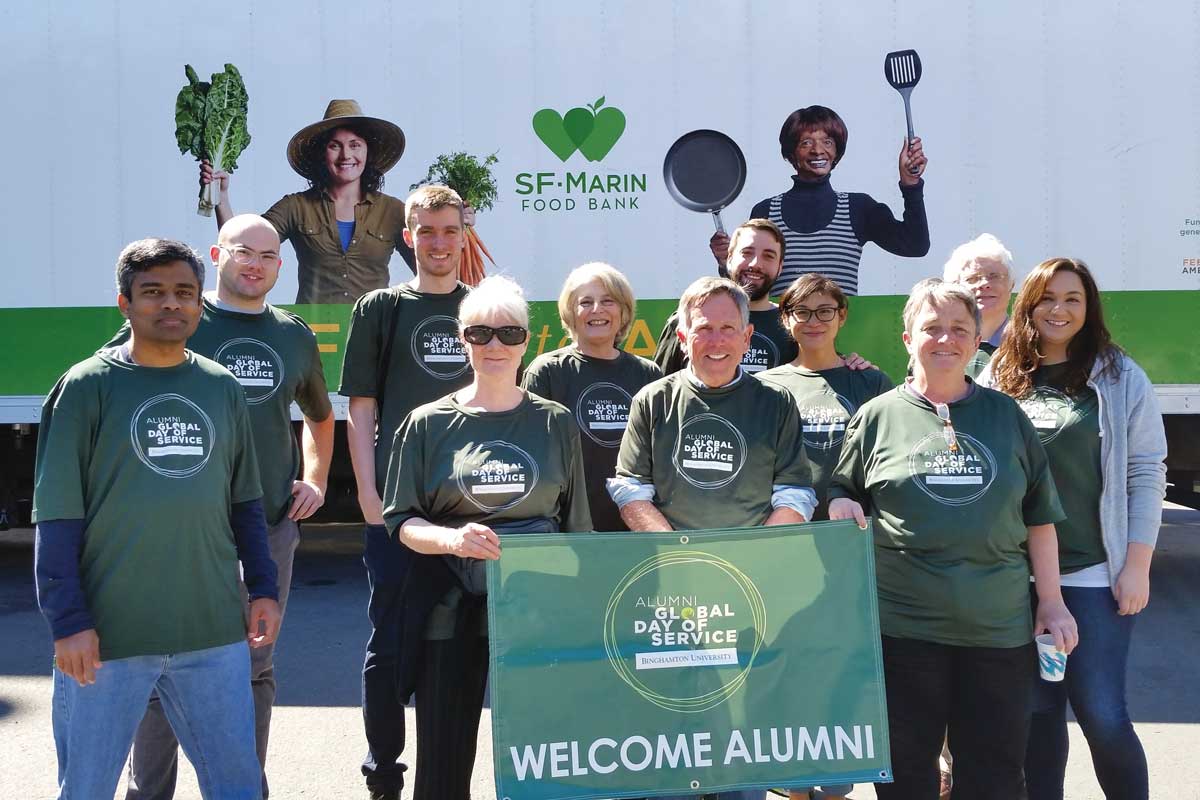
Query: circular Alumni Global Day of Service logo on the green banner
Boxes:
[{"xmin": 604, "ymin": 551, "xmax": 767, "ymax": 714}]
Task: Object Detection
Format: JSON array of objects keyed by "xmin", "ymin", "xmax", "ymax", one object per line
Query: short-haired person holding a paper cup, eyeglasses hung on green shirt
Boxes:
[{"xmin": 829, "ymin": 278, "xmax": 1078, "ymax": 800}]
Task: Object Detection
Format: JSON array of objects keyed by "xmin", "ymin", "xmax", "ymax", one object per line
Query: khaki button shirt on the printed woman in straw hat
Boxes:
[{"xmin": 263, "ymin": 188, "xmax": 413, "ymax": 303}]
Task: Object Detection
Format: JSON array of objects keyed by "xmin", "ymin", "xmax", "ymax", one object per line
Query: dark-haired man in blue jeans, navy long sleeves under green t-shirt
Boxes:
[{"xmin": 34, "ymin": 239, "xmax": 281, "ymax": 800}]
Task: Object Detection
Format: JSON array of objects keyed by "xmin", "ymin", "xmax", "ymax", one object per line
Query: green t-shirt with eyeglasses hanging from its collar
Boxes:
[{"xmin": 829, "ymin": 386, "xmax": 1063, "ymax": 648}]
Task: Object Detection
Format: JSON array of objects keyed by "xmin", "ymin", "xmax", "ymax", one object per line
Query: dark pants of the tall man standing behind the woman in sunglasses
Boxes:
[{"xmin": 362, "ymin": 525, "xmax": 408, "ymax": 793}]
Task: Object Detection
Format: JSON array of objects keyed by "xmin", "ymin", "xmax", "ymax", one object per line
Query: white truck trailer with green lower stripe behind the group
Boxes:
[{"xmin": 0, "ymin": 0, "xmax": 1200, "ymax": 523}]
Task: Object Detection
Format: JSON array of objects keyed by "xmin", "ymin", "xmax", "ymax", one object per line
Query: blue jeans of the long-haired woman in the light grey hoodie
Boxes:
[{"xmin": 1025, "ymin": 587, "xmax": 1150, "ymax": 800}]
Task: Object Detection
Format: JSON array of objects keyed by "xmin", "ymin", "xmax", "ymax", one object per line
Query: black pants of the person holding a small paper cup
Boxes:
[{"xmin": 875, "ymin": 636, "xmax": 1037, "ymax": 800}]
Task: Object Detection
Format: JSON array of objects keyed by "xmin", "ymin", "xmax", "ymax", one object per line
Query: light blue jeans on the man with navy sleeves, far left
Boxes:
[{"xmin": 52, "ymin": 642, "xmax": 263, "ymax": 800}]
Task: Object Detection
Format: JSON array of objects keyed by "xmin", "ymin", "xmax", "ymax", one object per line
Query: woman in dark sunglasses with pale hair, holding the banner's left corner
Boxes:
[{"xmin": 383, "ymin": 276, "xmax": 592, "ymax": 800}]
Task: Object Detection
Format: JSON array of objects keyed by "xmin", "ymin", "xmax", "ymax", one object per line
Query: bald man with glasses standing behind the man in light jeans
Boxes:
[{"xmin": 122, "ymin": 213, "xmax": 334, "ymax": 800}]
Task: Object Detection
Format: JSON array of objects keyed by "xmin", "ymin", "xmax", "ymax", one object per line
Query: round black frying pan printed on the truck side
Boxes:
[{"xmin": 662, "ymin": 130, "xmax": 746, "ymax": 233}]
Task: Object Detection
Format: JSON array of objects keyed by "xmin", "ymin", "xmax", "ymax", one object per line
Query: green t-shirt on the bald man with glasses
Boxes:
[{"xmin": 106, "ymin": 299, "xmax": 332, "ymax": 525}]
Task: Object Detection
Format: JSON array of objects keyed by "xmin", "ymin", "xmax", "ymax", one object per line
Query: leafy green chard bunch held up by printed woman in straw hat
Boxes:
[{"xmin": 175, "ymin": 64, "xmax": 250, "ymax": 217}]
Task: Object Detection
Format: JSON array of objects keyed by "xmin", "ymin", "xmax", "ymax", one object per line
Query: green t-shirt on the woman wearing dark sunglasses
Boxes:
[{"xmin": 383, "ymin": 393, "xmax": 592, "ymax": 533}]
